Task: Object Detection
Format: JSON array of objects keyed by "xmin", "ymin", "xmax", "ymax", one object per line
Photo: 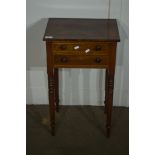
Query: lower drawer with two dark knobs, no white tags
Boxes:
[{"xmin": 54, "ymin": 55, "xmax": 108, "ymax": 68}]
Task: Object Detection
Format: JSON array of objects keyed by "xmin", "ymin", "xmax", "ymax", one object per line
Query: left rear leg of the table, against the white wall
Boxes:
[{"xmin": 54, "ymin": 68, "xmax": 59, "ymax": 112}]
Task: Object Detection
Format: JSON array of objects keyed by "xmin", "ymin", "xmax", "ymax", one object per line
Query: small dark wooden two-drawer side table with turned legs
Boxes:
[{"xmin": 43, "ymin": 18, "xmax": 120, "ymax": 137}]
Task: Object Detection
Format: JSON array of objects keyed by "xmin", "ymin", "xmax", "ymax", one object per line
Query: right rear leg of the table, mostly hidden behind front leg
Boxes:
[{"xmin": 104, "ymin": 69, "xmax": 108, "ymax": 113}]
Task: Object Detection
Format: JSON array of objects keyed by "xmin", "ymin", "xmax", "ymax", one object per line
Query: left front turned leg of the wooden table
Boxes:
[{"xmin": 48, "ymin": 72, "xmax": 55, "ymax": 136}]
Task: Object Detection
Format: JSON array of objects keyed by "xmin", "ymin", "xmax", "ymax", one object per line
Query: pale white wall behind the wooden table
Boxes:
[{"xmin": 27, "ymin": 0, "xmax": 129, "ymax": 106}]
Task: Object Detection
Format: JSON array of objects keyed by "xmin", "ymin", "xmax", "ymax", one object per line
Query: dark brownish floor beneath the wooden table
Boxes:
[{"xmin": 26, "ymin": 105, "xmax": 129, "ymax": 155}]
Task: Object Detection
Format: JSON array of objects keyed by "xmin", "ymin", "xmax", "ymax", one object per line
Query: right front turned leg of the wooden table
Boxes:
[{"xmin": 106, "ymin": 72, "xmax": 114, "ymax": 137}]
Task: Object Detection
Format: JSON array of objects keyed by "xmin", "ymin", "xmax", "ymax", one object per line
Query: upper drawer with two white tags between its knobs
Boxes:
[{"xmin": 52, "ymin": 41, "xmax": 112, "ymax": 55}]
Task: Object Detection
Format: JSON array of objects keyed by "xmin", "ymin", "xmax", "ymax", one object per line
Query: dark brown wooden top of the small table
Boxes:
[{"xmin": 43, "ymin": 18, "xmax": 120, "ymax": 42}]
